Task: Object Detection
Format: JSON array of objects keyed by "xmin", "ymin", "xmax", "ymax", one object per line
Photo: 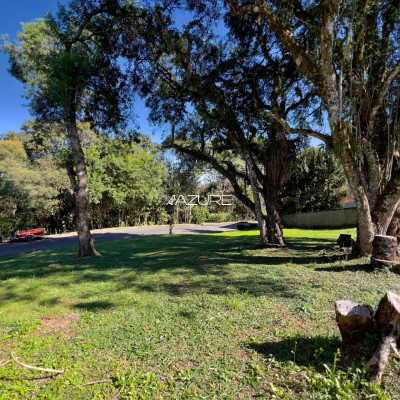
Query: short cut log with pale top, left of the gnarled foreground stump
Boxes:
[{"xmin": 335, "ymin": 300, "xmax": 374, "ymax": 343}]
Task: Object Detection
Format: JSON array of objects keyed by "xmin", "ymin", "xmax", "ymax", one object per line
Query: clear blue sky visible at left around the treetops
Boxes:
[{"xmin": 0, "ymin": 0, "xmax": 162, "ymax": 143}]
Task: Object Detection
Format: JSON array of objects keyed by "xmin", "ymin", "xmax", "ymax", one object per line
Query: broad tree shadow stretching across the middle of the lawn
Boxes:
[{"xmin": 0, "ymin": 233, "xmax": 360, "ymax": 304}]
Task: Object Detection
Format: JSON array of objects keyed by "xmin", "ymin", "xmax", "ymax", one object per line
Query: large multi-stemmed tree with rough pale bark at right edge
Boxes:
[{"xmin": 228, "ymin": 0, "xmax": 400, "ymax": 255}]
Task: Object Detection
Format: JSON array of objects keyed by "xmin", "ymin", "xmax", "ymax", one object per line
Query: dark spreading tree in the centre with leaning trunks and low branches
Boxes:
[{"xmin": 123, "ymin": 4, "xmax": 312, "ymax": 244}]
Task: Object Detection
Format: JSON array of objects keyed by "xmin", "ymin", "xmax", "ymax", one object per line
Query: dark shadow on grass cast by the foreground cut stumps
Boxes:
[{"xmin": 248, "ymin": 336, "xmax": 342, "ymax": 372}]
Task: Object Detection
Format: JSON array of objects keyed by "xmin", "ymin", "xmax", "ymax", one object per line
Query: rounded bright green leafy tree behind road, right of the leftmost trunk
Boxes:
[{"xmin": 85, "ymin": 135, "xmax": 166, "ymax": 226}]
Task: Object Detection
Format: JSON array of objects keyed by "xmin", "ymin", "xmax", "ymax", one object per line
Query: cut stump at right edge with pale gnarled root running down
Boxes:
[{"xmin": 365, "ymin": 292, "xmax": 400, "ymax": 385}]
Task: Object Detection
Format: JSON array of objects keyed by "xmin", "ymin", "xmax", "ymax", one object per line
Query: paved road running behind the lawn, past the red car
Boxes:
[{"xmin": 0, "ymin": 222, "xmax": 236, "ymax": 256}]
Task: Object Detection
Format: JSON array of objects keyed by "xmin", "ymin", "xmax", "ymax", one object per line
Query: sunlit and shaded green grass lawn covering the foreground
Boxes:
[{"xmin": 0, "ymin": 229, "xmax": 400, "ymax": 400}]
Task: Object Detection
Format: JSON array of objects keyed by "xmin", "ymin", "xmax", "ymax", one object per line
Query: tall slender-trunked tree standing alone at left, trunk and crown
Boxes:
[{"xmin": 4, "ymin": 0, "xmax": 130, "ymax": 257}]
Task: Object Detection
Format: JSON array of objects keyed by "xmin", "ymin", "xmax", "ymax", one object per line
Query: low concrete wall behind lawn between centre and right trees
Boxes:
[{"xmin": 282, "ymin": 208, "xmax": 357, "ymax": 228}]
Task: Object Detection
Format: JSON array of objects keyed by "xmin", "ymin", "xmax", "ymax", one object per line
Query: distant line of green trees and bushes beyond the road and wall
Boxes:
[{"xmin": 0, "ymin": 120, "xmax": 344, "ymax": 236}]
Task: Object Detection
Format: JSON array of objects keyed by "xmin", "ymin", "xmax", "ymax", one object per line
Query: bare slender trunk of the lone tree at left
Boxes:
[{"xmin": 66, "ymin": 104, "xmax": 99, "ymax": 257}]
